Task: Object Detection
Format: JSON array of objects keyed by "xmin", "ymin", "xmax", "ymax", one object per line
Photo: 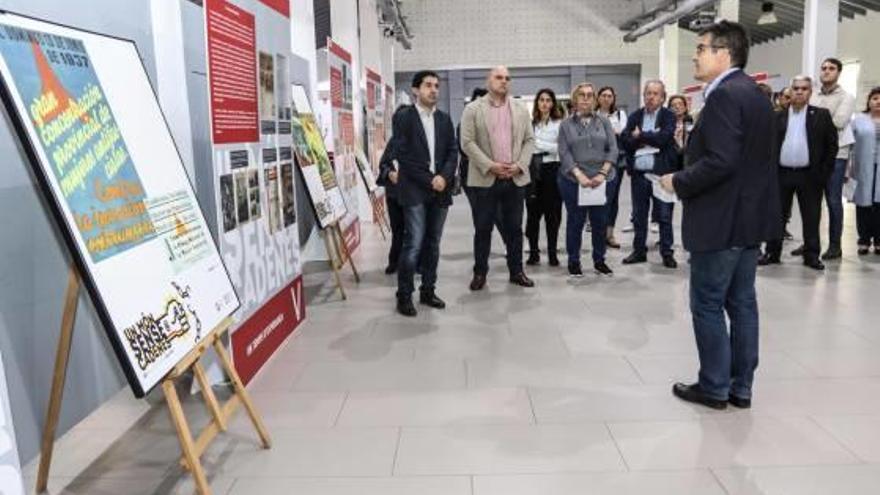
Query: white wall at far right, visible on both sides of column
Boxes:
[{"xmin": 748, "ymin": 12, "xmax": 880, "ymax": 104}]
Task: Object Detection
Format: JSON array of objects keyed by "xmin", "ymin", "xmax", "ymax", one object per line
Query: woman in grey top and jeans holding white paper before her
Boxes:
[{"xmin": 557, "ymin": 83, "xmax": 618, "ymax": 277}]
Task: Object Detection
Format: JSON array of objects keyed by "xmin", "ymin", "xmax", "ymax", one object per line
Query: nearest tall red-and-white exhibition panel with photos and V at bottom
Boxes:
[{"xmin": 204, "ymin": 0, "xmax": 305, "ymax": 383}]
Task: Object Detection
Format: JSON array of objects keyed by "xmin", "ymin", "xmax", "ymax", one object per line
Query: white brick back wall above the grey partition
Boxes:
[{"xmin": 396, "ymin": 0, "xmax": 659, "ymax": 88}]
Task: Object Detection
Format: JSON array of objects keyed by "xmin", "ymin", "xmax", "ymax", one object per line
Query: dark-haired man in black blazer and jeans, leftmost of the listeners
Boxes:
[{"xmin": 386, "ymin": 71, "xmax": 458, "ymax": 316}]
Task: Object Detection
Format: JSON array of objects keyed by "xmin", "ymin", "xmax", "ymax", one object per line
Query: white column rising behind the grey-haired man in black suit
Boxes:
[{"xmin": 801, "ymin": 0, "xmax": 840, "ymax": 79}]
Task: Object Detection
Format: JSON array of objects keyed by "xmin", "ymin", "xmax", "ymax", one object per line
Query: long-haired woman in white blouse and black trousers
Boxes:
[{"xmin": 526, "ymin": 89, "xmax": 563, "ymax": 266}]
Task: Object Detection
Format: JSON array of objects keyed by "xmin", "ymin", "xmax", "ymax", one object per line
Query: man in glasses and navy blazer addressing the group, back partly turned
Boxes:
[{"xmin": 660, "ymin": 21, "xmax": 782, "ymax": 409}]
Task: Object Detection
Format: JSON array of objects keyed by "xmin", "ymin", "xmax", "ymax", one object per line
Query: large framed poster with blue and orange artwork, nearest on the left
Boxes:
[{"xmin": 0, "ymin": 13, "xmax": 239, "ymax": 397}]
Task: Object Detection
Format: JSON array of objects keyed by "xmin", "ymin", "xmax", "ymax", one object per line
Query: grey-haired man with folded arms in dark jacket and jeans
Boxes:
[{"xmin": 620, "ymin": 80, "xmax": 680, "ymax": 268}]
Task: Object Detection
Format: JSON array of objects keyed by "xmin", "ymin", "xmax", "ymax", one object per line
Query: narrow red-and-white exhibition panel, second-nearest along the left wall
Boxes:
[{"xmin": 327, "ymin": 39, "xmax": 360, "ymax": 252}]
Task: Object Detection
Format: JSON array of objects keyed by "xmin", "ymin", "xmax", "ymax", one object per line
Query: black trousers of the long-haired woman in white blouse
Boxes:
[{"xmin": 526, "ymin": 162, "xmax": 562, "ymax": 254}]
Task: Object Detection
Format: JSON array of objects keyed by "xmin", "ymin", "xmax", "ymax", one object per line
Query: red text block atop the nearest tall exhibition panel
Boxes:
[{"xmin": 205, "ymin": 0, "xmax": 260, "ymax": 144}]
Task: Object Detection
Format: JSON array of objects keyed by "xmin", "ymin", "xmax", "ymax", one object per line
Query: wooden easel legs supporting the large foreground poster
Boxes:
[{"xmin": 36, "ymin": 268, "xmax": 272, "ymax": 495}]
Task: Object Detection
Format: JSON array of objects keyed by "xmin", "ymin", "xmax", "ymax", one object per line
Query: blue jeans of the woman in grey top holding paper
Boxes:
[{"xmin": 556, "ymin": 174, "xmax": 608, "ymax": 263}]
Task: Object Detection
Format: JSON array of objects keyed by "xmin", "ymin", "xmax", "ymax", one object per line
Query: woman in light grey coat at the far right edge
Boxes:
[{"xmin": 852, "ymin": 86, "xmax": 880, "ymax": 255}]
